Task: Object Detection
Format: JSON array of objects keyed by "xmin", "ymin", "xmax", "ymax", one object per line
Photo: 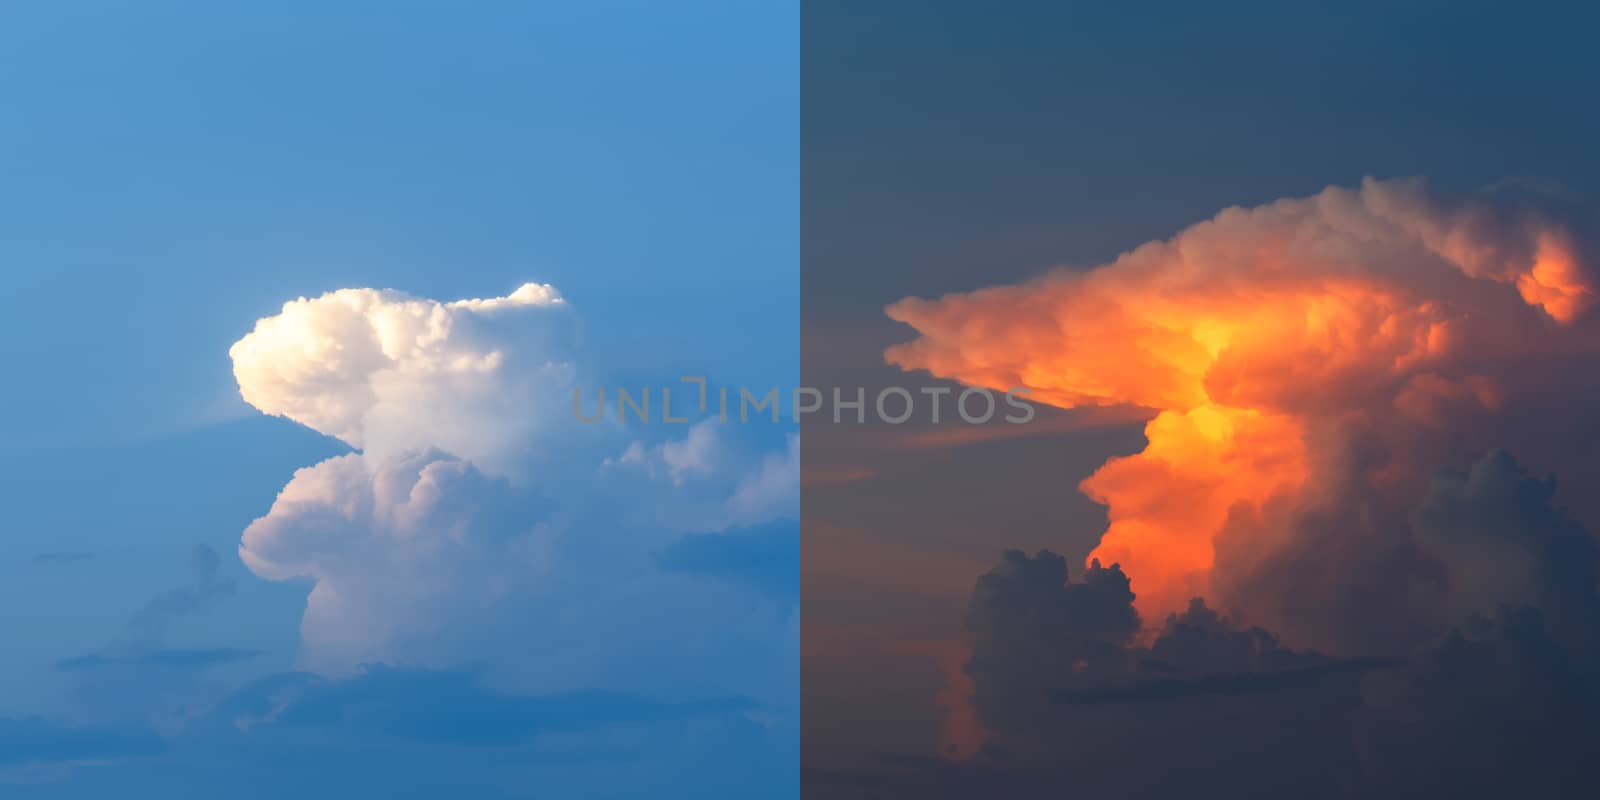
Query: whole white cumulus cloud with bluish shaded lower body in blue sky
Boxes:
[{"xmin": 230, "ymin": 283, "xmax": 798, "ymax": 702}]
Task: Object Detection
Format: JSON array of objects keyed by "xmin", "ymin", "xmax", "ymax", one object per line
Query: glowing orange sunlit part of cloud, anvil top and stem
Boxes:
[{"xmin": 885, "ymin": 179, "xmax": 1594, "ymax": 619}]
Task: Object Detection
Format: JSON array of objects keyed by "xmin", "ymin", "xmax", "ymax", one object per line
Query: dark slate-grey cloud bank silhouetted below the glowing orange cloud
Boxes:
[{"xmin": 838, "ymin": 451, "xmax": 1600, "ymax": 798}]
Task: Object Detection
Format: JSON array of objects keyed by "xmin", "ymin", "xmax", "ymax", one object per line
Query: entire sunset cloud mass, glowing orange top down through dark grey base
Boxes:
[{"xmin": 870, "ymin": 179, "xmax": 1600, "ymax": 797}]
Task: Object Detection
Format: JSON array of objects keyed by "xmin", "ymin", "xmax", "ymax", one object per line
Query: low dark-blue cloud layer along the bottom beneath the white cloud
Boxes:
[{"xmin": 0, "ymin": 666, "xmax": 794, "ymax": 800}]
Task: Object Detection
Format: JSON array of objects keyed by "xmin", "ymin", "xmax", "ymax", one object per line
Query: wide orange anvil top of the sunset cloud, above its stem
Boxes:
[{"xmin": 888, "ymin": 179, "xmax": 1595, "ymax": 410}]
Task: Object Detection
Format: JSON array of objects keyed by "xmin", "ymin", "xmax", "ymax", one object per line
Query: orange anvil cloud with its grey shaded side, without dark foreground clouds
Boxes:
[{"xmin": 886, "ymin": 179, "xmax": 1600, "ymax": 654}]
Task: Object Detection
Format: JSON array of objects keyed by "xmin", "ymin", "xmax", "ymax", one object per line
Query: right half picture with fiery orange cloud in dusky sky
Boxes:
[{"xmin": 806, "ymin": 0, "xmax": 1600, "ymax": 800}]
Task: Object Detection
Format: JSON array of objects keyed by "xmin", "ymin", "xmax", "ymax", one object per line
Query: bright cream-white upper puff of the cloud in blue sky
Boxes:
[{"xmin": 229, "ymin": 283, "xmax": 574, "ymax": 467}]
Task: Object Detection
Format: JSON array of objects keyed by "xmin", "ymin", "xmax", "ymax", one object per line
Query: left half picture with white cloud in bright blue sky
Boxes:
[{"xmin": 0, "ymin": 0, "xmax": 800, "ymax": 800}]
